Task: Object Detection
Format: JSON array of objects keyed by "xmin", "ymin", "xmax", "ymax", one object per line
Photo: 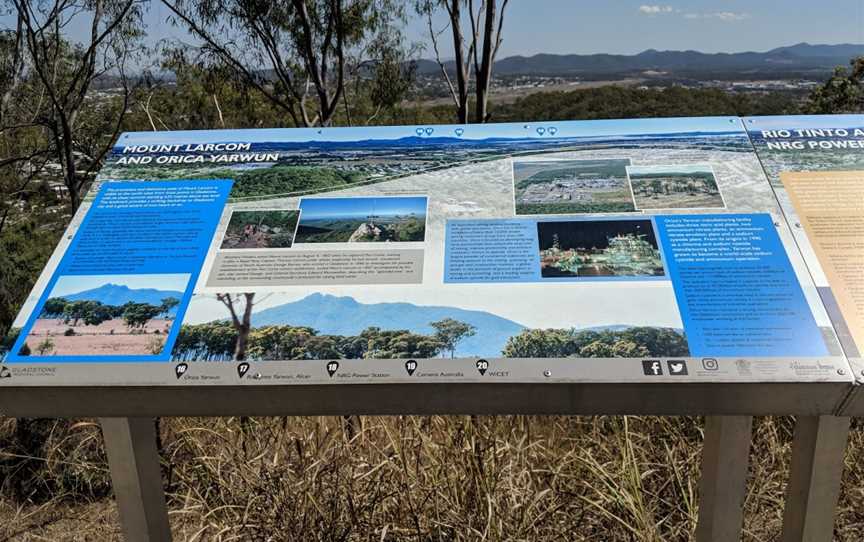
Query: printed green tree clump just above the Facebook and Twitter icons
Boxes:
[{"xmin": 503, "ymin": 327, "xmax": 690, "ymax": 358}]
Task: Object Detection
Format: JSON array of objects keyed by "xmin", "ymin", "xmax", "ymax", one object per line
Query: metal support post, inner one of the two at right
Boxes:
[{"xmin": 695, "ymin": 416, "xmax": 753, "ymax": 542}]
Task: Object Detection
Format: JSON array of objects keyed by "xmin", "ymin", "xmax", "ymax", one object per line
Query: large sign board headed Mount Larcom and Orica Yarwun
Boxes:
[{"xmin": 0, "ymin": 117, "xmax": 851, "ymax": 414}]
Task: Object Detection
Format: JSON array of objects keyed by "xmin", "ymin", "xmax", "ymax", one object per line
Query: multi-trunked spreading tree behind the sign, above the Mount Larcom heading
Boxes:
[{"xmin": 163, "ymin": 0, "xmax": 418, "ymax": 126}]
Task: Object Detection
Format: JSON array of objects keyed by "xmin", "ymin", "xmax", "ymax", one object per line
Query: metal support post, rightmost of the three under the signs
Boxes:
[{"xmin": 781, "ymin": 416, "xmax": 849, "ymax": 542}]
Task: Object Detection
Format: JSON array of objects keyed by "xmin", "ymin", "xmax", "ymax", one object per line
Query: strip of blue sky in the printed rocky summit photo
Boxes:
[{"xmin": 300, "ymin": 197, "xmax": 426, "ymax": 223}]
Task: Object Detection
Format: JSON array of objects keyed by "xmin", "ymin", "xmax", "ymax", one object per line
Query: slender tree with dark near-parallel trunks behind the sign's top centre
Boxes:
[{"xmin": 415, "ymin": 0, "xmax": 508, "ymax": 123}]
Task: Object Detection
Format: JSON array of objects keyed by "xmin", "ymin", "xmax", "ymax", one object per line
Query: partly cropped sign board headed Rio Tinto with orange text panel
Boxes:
[{"xmin": 745, "ymin": 115, "xmax": 864, "ymax": 414}]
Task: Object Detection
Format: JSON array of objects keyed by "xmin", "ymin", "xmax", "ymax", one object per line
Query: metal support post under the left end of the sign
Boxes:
[{"xmin": 99, "ymin": 418, "xmax": 171, "ymax": 542}]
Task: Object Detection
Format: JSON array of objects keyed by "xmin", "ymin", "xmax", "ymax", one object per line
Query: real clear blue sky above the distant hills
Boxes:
[{"xmin": 6, "ymin": 0, "xmax": 864, "ymax": 58}]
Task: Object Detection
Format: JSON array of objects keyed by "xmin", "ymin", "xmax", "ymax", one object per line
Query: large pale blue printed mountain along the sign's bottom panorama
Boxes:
[{"xmin": 246, "ymin": 294, "xmax": 525, "ymax": 357}]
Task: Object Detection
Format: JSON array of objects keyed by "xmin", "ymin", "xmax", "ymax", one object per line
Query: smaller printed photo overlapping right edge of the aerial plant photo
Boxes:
[{"xmin": 627, "ymin": 164, "xmax": 726, "ymax": 210}]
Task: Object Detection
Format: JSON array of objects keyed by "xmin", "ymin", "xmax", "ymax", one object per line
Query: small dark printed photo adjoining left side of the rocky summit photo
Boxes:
[{"xmin": 221, "ymin": 210, "xmax": 300, "ymax": 249}]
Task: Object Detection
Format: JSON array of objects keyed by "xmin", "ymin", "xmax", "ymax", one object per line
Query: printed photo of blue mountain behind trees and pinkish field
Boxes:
[{"xmin": 20, "ymin": 274, "xmax": 189, "ymax": 356}]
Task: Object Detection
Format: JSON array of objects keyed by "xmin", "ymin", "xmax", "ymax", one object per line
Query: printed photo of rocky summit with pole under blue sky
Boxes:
[{"xmin": 296, "ymin": 196, "xmax": 426, "ymax": 243}]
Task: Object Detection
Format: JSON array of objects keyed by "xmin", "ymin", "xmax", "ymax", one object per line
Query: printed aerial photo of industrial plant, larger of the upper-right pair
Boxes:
[{"xmin": 513, "ymin": 158, "xmax": 635, "ymax": 215}]
